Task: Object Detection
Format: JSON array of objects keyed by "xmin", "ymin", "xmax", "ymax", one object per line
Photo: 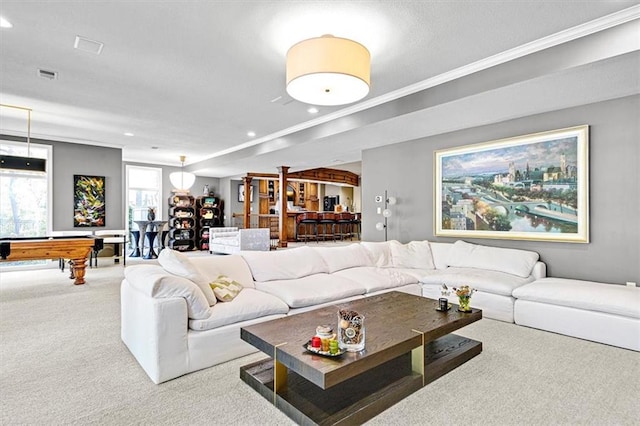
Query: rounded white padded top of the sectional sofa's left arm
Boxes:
[{"xmin": 124, "ymin": 265, "xmax": 211, "ymax": 319}]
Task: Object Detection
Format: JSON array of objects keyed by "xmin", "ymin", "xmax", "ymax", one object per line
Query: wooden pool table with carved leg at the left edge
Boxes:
[{"xmin": 0, "ymin": 236, "xmax": 103, "ymax": 285}]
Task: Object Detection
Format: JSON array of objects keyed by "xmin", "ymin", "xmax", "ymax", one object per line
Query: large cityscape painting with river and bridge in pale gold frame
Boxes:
[{"xmin": 434, "ymin": 125, "xmax": 589, "ymax": 243}]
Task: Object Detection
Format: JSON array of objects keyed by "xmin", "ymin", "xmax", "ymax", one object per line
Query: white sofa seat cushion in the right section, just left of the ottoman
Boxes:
[{"xmin": 420, "ymin": 267, "xmax": 534, "ymax": 296}]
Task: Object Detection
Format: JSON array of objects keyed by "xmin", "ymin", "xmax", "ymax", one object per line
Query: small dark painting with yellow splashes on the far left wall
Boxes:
[{"xmin": 73, "ymin": 175, "xmax": 105, "ymax": 228}]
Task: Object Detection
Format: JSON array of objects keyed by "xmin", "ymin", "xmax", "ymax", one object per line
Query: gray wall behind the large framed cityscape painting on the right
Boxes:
[{"xmin": 362, "ymin": 96, "xmax": 640, "ymax": 283}]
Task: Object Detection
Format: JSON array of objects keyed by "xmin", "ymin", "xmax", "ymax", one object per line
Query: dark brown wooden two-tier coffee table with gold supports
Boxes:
[{"xmin": 240, "ymin": 291, "xmax": 482, "ymax": 425}]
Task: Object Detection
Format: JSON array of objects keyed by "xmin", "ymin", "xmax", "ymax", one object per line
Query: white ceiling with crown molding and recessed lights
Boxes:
[{"xmin": 0, "ymin": 0, "xmax": 640, "ymax": 177}]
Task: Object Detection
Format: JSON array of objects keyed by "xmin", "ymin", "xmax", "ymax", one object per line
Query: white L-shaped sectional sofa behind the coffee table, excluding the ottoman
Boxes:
[{"xmin": 121, "ymin": 241, "xmax": 545, "ymax": 383}]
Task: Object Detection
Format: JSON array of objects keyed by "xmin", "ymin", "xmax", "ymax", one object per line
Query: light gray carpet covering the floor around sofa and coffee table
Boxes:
[{"xmin": 0, "ymin": 259, "xmax": 640, "ymax": 425}]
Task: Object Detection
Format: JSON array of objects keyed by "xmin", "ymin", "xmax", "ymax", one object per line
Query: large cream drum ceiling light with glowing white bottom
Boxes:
[{"xmin": 287, "ymin": 35, "xmax": 371, "ymax": 105}]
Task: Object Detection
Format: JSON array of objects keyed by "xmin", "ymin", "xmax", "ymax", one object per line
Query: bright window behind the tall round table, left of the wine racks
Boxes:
[{"xmin": 126, "ymin": 166, "xmax": 163, "ymax": 229}]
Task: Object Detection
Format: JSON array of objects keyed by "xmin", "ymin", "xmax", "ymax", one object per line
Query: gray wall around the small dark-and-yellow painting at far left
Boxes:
[{"xmin": 0, "ymin": 135, "xmax": 125, "ymax": 231}]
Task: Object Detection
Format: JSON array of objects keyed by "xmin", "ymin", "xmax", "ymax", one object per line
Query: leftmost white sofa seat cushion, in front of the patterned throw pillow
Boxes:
[{"xmin": 189, "ymin": 288, "xmax": 289, "ymax": 330}]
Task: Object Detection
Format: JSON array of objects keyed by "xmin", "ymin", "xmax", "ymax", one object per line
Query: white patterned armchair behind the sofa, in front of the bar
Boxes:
[{"xmin": 209, "ymin": 228, "xmax": 271, "ymax": 254}]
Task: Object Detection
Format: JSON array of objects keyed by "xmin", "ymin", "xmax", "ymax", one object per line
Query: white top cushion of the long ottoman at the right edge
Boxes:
[{"xmin": 513, "ymin": 278, "xmax": 640, "ymax": 318}]
